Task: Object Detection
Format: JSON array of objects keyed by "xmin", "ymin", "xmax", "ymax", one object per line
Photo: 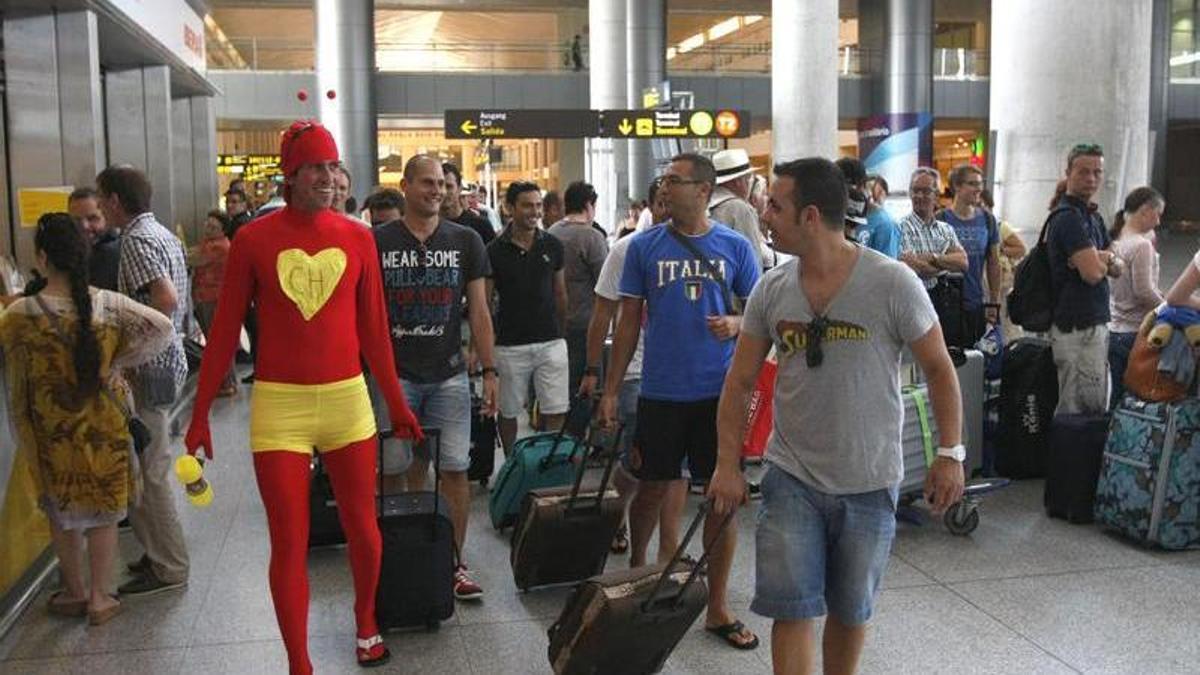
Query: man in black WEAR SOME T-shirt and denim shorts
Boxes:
[{"xmin": 373, "ymin": 155, "xmax": 497, "ymax": 599}]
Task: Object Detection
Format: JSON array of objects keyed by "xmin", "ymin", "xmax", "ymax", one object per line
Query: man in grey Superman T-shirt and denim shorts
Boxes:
[{"xmin": 709, "ymin": 157, "xmax": 966, "ymax": 673}]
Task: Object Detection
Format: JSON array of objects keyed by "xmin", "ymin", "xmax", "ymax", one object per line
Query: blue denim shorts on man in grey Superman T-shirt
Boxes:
[{"xmin": 750, "ymin": 466, "xmax": 898, "ymax": 626}]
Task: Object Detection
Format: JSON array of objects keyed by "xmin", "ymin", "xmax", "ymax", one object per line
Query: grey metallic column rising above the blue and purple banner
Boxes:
[{"xmin": 880, "ymin": 0, "xmax": 934, "ymax": 113}]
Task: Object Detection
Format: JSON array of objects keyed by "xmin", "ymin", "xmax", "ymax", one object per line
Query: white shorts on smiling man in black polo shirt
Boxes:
[{"xmin": 496, "ymin": 339, "xmax": 571, "ymax": 419}]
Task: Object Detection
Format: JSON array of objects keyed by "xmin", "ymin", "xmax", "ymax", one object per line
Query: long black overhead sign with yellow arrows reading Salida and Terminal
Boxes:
[{"xmin": 444, "ymin": 108, "xmax": 750, "ymax": 139}]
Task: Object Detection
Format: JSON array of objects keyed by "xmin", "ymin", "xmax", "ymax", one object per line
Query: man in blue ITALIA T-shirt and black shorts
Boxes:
[{"xmin": 600, "ymin": 154, "xmax": 758, "ymax": 649}]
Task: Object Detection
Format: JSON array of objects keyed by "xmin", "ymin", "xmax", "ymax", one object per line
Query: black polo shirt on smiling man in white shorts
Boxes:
[{"xmin": 487, "ymin": 226, "xmax": 563, "ymax": 346}]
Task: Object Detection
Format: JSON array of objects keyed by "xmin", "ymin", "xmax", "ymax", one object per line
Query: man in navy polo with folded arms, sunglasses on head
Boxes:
[{"xmin": 1046, "ymin": 144, "xmax": 1122, "ymax": 414}]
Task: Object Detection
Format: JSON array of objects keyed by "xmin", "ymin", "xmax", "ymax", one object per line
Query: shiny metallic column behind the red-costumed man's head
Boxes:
[{"xmin": 316, "ymin": 0, "xmax": 379, "ymax": 204}]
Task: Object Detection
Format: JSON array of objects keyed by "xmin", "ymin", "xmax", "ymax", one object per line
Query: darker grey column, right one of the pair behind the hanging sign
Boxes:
[{"xmin": 625, "ymin": 0, "xmax": 667, "ymax": 199}]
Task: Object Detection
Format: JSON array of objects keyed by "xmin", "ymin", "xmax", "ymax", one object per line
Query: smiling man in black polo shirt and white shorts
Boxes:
[{"xmin": 487, "ymin": 180, "xmax": 570, "ymax": 453}]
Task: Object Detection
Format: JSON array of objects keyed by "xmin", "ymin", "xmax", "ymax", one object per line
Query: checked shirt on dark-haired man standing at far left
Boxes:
[{"xmin": 116, "ymin": 213, "xmax": 192, "ymax": 388}]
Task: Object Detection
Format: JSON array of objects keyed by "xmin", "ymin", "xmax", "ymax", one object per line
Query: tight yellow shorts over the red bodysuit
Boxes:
[{"xmin": 250, "ymin": 375, "xmax": 376, "ymax": 455}]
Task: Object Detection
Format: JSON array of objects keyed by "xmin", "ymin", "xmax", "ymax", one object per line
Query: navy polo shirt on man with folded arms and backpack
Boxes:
[{"xmin": 1046, "ymin": 195, "xmax": 1112, "ymax": 330}]
